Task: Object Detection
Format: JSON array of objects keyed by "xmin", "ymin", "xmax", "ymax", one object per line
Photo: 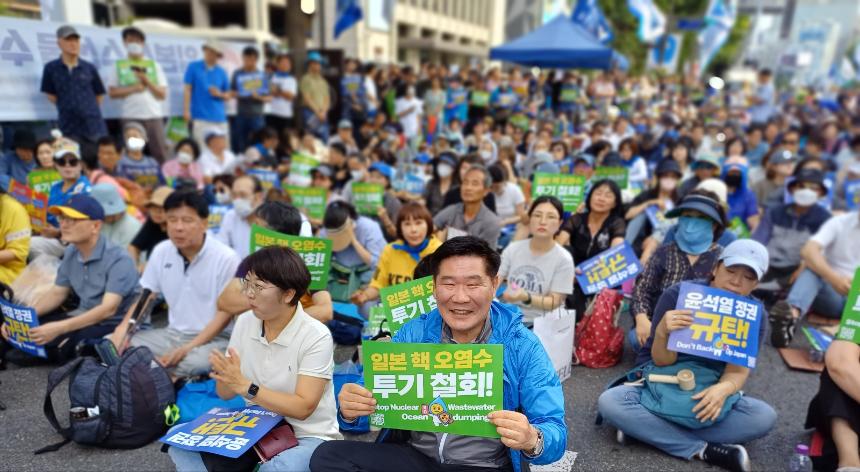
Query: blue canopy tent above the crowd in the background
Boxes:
[{"xmin": 490, "ymin": 15, "xmax": 612, "ymax": 69}]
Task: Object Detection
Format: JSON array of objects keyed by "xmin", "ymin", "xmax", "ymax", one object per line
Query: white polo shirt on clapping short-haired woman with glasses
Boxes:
[{"xmin": 229, "ymin": 303, "xmax": 342, "ymax": 440}]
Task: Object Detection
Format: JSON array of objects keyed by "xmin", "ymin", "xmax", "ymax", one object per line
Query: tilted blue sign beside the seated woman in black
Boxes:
[{"xmin": 576, "ymin": 243, "xmax": 642, "ymax": 295}]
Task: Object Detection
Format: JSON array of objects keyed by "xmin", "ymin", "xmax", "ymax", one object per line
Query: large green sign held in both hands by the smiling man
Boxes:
[{"xmin": 362, "ymin": 341, "xmax": 503, "ymax": 438}]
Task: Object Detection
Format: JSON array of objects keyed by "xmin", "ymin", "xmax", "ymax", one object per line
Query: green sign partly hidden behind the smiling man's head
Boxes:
[{"xmin": 379, "ymin": 276, "xmax": 436, "ymax": 335}]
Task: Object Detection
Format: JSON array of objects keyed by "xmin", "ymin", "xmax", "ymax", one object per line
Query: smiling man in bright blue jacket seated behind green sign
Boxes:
[{"xmin": 310, "ymin": 236, "xmax": 567, "ymax": 472}]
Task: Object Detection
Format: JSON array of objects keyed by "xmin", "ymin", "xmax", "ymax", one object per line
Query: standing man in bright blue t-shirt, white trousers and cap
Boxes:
[{"xmin": 182, "ymin": 41, "xmax": 232, "ymax": 146}]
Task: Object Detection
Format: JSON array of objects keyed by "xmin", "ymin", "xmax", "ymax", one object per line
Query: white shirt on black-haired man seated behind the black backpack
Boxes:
[{"xmin": 140, "ymin": 234, "xmax": 240, "ymax": 334}]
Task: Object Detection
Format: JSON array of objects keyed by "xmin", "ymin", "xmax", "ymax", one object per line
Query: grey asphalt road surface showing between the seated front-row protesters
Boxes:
[{"xmin": 0, "ymin": 314, "xmax": 818, "ymax": 472}]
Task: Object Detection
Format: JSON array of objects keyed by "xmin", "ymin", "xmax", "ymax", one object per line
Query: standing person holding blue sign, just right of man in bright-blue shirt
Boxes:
[{"xmin": 230, "ymin": 46, "xmax": 272, "ymax": 153}]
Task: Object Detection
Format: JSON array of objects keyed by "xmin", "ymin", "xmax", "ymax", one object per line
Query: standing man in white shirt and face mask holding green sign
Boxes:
[{"xmin": 108, "ymin": 26, "xmax": 168, "ymax": 164}]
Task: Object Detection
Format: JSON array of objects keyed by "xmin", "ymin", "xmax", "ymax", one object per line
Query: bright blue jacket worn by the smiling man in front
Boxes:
[{"xmin": 386, "ymin": 301, "xmax": 567, "ymax": 472}]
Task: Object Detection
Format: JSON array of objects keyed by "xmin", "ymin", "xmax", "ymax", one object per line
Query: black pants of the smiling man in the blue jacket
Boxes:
[{"xmin": 311, "ymin": 441, "xmax": 513, "ymax": 472}]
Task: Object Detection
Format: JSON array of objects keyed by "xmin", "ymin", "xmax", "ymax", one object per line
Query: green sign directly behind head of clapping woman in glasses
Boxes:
[{"xmin": 251, "ymin": 225, "xmax": 331, "ymax": 290}]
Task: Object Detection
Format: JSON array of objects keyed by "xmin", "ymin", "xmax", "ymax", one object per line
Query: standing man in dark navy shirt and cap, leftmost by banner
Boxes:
[{"xmin": 41, "ymin": 25, "xmax": 107, "ymax": 153}]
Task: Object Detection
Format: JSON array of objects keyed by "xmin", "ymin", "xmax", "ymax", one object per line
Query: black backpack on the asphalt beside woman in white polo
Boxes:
[{"xmin": 35, "ymin": 346, "xmax": 176, "ymax": 454}]
